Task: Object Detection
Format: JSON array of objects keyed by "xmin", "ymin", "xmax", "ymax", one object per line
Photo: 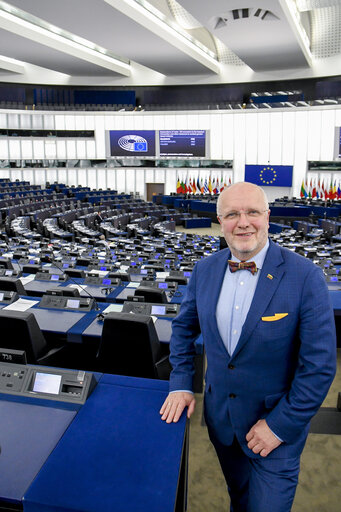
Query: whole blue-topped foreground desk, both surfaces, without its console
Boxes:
[{"xmin": 0, "ymin": 365, "xmax": 188, "ymax": 512}]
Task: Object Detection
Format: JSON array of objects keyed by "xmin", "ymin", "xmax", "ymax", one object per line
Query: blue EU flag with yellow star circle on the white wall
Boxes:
[{"xmin": 245, "ymin": 165, "xmax": 293, "ymax": 187}]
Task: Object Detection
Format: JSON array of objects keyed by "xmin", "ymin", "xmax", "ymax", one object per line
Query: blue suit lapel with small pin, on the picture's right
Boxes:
[{"xmin": 232, "ymin": 241, "xmax": 285, "ymax": 357}]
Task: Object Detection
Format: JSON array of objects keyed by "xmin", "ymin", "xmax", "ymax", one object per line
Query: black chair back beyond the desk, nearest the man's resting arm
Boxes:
[{"xmin": 97, "ymin": 313, "xmax": 160, "ymax": 378}]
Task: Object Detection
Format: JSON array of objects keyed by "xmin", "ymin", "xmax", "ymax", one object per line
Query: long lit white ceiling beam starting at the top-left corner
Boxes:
[{"xmin": 0, "ymin": 1, "xmax": 131, "ymax": 76}]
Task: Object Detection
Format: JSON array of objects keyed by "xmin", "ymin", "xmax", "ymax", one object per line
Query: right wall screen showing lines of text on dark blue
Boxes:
[{"xmin": 159, "ymin": 130, "xmax": 208, "ymax": 158}]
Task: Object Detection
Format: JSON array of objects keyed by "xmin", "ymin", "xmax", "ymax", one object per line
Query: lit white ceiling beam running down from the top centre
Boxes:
[{"xmin": 105, "ymin": 0, "xmax": 220, "ymax": 74}]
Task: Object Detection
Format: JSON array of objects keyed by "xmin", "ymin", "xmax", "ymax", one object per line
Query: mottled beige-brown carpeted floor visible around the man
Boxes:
[{"xmin": 178, "ymin": 224, "xmax": 341, "ymax": 512}]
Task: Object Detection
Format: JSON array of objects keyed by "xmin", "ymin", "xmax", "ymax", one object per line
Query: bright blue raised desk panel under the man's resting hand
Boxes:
[{"xmin": 24, "ymin": 375, "xmax": 186, "ymax": 512}]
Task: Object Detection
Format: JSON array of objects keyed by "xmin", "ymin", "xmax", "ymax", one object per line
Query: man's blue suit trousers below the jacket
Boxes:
[{"xmin": 210, "ymin": 434, "xmax": 300, "ymax": 512}]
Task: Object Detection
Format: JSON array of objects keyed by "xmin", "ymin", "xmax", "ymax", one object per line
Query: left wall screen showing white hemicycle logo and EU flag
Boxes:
[{"xmin": 107, "ymin": 130, "xmax": 156, "ymax": 158}]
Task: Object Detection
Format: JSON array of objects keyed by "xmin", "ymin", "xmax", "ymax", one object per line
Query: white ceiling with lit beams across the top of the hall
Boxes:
[{"xmin": 0, "ymin": 0, "xmax": 341, "ymax": 86}]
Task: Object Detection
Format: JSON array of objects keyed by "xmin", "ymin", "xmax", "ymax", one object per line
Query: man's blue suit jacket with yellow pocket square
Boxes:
[{"xmin": 170, "ymin": 241, "xmax": 336, "ymax": 458}]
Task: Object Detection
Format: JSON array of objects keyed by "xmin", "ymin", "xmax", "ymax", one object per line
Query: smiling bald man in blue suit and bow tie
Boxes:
[{"xmin": 160, "ymin": 182, "xmax": 336, "ymax": 512}]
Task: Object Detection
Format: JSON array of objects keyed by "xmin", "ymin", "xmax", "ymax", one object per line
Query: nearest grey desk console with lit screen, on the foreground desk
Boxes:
[{"xmin": 0, "ymin": 363, "xmax": 96, "ymax": 404}]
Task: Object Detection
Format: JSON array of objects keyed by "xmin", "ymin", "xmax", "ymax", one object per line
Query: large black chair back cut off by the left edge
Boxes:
[{"xmin": 0, "ymin": 309, "xmax": 46, "ymax": 364}]
